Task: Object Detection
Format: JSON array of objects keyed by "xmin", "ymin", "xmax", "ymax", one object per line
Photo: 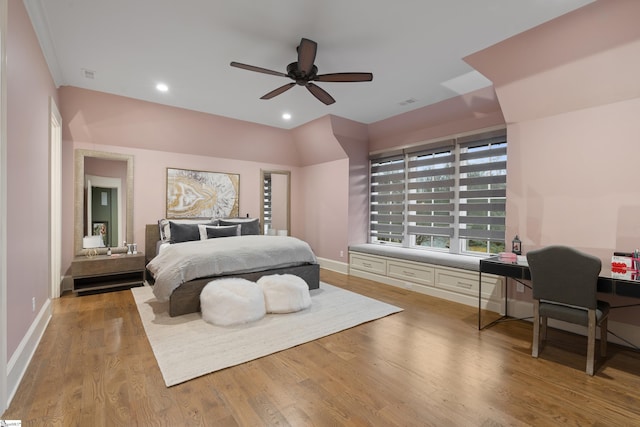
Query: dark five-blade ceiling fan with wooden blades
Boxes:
[{"xmin": 231, "ymin": 38, "xmax": 373, "ymax": 105}]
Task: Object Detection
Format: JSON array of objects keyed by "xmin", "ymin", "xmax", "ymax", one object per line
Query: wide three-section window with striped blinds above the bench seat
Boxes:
[{"xmin": 370, "ymin": 130, "xmax": 507, "ymax": 253}]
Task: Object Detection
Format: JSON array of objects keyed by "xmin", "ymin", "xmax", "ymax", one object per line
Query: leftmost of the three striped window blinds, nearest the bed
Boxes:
[{"xmin": 370, "ymin": 155, "xmax": 405, "ymax": 243}]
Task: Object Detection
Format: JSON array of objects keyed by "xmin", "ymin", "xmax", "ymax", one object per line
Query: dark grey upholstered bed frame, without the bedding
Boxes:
[{"xmin": 145, "ymin": 224, "xmax": 320, "ymax": 317}]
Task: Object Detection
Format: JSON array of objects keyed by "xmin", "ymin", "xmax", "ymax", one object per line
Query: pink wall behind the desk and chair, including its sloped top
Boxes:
[{"xmin": 466, "ymin": 1, "xmax": 640, "ymax": 325}]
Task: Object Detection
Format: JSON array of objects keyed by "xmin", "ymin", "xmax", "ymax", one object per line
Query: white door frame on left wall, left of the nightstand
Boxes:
[{"xmin": 49, "ymin": 97, "xmax": 62, "ymax": 298}]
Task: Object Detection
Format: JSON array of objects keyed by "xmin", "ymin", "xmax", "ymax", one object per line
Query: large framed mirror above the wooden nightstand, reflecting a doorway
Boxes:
[{"xmin": 74, "ymin": 149, "xmax": 133, "ymax": 255}]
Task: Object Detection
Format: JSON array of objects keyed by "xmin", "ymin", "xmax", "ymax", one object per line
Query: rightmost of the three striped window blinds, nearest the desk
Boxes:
[{"xmin": 458, "ymin": 134, "xmax": 507, "ymax": 241}]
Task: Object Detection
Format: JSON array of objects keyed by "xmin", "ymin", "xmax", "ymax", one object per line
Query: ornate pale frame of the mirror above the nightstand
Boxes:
[{"xmin": 73, "ymin": 148, "xmax": 133, "ymax": 255}]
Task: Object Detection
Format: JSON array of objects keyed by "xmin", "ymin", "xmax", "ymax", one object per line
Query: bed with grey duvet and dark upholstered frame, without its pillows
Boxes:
[{"xmin": 145, "ymin": 224, "xmax": 320, "ymax": 317}]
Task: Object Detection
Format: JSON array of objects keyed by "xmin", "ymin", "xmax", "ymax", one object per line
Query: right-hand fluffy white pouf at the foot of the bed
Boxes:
[{"xmin": 257, "ymin": 274, "xmax": 311, "ymax": 313}]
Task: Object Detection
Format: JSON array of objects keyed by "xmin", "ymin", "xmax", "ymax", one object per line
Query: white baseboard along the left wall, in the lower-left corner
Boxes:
[{"xmin": 7, "ymin": 299, "xmax": 51, "ymax": 407}]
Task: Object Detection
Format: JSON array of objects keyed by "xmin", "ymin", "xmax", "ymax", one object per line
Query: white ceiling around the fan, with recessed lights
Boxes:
[{"xmin": 24, "ymin": 0, "xmax": 592, "ymax": 128}]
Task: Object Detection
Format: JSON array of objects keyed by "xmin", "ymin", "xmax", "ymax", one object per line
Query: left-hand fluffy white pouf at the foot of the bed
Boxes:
[{"xmin": 200, "ymin": 278, "xmax": 266, "ymax": 326}]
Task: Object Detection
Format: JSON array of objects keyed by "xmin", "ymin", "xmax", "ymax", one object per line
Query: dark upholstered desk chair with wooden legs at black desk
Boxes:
[{"xmin": 527, "ymin": 246, "xmax": 609, "ymax": 375}]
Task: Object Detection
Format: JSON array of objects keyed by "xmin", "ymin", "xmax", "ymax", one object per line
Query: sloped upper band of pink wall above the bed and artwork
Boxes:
[{"xmin": 59, "ymin": 86, "xmax": 300, "ymax": 165}]
